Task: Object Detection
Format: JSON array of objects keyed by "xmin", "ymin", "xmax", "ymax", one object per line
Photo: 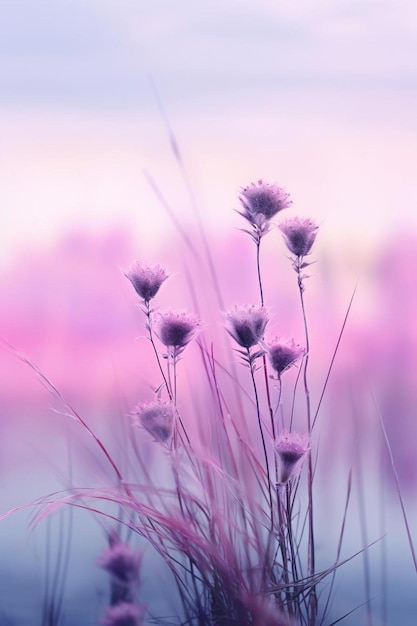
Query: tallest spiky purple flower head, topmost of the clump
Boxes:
[{"xmin": 240, "ymin": 180, "xmax": 292, "ymax": 232}]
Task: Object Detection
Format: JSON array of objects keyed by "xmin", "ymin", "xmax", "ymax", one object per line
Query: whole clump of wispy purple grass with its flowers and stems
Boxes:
[{"xmin": 3, "ymin": 181, "xmax": 378, "ymax": 626}]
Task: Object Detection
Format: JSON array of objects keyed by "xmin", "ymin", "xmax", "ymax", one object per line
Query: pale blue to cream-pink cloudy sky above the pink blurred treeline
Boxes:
[{"xmin": 0, "ymin": 0, "xmax": 417, "ymax": 264}]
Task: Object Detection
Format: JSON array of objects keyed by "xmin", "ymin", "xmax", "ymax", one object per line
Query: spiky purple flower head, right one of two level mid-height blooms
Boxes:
[{"xmin": 225, "ymin": 305, "xmax": 268, "ymax": 349}]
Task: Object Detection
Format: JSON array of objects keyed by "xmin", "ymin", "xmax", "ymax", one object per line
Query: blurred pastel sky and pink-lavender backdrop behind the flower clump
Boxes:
[{"xmin": 0, "ymin": 0, "xmax": 417, "ymax": 626}]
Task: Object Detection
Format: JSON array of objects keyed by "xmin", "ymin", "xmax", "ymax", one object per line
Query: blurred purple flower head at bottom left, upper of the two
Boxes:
[{"xmin": 97, "ymin": 539, "xmax": 142, "ymax": 584}]
